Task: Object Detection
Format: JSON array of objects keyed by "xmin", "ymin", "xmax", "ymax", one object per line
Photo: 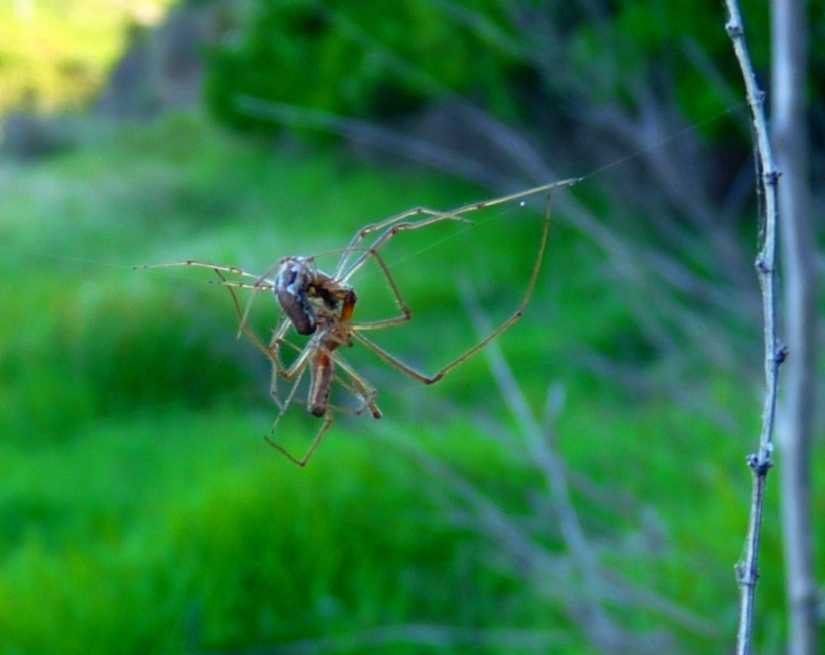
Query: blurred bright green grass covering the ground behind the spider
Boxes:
[{"xmin": 0, "ymin": 116, "xmax": 825, "ymax": 653}]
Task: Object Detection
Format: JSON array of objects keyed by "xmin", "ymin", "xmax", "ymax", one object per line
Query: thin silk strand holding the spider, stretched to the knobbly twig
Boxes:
[{"xmin": 0, "ymin": 101, "xmax": 748, "ymax": 280}]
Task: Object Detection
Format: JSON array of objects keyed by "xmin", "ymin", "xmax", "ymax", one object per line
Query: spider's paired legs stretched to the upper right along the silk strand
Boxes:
[{"xmin": 335, "ymin": 177, "xmax": 583, "ymax": 283}]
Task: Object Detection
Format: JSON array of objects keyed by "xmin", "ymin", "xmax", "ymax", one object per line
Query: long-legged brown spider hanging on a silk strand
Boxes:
[{"xmin": 142, "ymin": 178, "xmax": 581, "ymax": 467}]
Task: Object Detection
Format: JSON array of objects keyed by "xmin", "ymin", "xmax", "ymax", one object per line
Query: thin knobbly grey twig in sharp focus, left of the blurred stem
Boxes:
[{"xmin": 725, "ymin": 0, "xmax": 786, "ymax": 655}]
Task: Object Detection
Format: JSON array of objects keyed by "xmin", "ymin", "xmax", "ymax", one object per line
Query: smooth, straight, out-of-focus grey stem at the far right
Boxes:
[{"xmin": 771, "ymin": 0, "xmax": 819, "ymax": 655}]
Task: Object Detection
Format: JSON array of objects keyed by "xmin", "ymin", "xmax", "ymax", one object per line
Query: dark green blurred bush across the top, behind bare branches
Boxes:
[{"xmin": 206, "ymin": 0, "xmax": 825, "ymax": 140}]
